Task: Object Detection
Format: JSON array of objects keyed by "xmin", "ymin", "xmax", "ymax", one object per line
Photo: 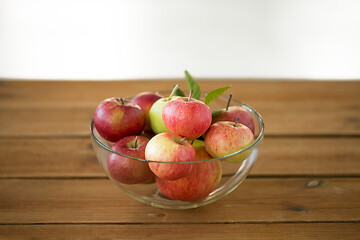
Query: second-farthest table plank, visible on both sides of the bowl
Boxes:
[{"xmin": 0, "ymin": 101, "xmax": 360, "ymax": 137}]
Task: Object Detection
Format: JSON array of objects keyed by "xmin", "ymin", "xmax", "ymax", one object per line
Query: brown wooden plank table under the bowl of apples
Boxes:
[{"xmin": 0, "ymin": 80, "xmax": 360, "ymax": 239}]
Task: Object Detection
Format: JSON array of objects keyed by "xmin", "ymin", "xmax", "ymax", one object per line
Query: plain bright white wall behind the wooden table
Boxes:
[{"xmin": 0, "ymin": 0, "xmax": 360, "ymax": 79}]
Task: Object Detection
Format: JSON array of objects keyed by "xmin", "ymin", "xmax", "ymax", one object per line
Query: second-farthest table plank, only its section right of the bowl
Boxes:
[{"xmin": 253, "ymin": 100, "xmax": 360, "ymax": 135}]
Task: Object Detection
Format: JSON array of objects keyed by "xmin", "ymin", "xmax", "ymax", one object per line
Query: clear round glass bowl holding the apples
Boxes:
[{"xmin": 90, "ymin": 91, "xmax": 264, "ymax": 209}]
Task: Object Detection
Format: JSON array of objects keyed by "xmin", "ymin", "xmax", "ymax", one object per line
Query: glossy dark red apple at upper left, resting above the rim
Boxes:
[{"xmin": 94, "ymin": 97, "xmax": 145, "ymax": 142}]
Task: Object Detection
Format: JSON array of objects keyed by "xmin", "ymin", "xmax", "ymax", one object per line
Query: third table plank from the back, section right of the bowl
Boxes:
[{"xmin": 252, "ymin": 137, "xmax": 360, "ymax": 176}]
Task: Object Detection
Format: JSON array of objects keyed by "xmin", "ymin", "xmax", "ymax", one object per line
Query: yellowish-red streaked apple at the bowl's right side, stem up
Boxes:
[{"xmin": 204, "ymin": 120, "xmax": 254, "ymax": 163}]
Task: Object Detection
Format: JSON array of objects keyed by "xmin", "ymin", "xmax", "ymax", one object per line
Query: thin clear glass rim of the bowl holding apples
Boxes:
[{"xmin": 90, "ymin": 94, "xmax": 265, "ymax": 164}]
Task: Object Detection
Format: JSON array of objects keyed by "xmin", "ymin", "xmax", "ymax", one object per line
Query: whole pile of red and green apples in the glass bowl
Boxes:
[{"xmin": 94, "ymin": 76, "xmax": 254, "ymax": 201}]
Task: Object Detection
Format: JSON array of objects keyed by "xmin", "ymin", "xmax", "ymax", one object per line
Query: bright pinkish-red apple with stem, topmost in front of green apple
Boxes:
[{"xmin": 162, "ymin": 92, "xmax": 212, "ymax": 139}]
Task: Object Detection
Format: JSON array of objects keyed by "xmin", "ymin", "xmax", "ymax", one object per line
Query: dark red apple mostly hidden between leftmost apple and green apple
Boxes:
[{"xmin": 131, "ymin": 92, "xmax": 161, "ymax": 131}]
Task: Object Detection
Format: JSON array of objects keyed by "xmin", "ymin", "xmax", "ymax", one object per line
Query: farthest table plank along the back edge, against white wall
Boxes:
[{"xmin": 0, "ymin": 78, "xmax": 360, "ymax": 106}]
